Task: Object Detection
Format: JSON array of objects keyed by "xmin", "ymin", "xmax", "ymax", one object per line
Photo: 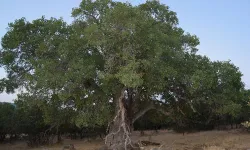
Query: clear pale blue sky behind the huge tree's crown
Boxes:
[{"xmin": 0, "ymin": 0, "xmax": 250, "ymax": 101}]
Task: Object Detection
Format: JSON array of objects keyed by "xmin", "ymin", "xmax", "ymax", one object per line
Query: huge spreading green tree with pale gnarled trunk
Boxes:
[{"xmin": 0, "ymin": 0, "xmax": 243, "ymax": 149}]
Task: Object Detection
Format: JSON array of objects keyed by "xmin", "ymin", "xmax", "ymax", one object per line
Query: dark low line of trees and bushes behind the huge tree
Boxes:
[{"xmin": 0, "ymin": 86, "xmax": 250, "ymax": 147}]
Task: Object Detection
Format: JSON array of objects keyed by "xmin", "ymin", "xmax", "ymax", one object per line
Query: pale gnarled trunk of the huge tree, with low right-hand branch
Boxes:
[{"xmin": 105, "ymin": 89, "xmax": 169, "ymax": 150}]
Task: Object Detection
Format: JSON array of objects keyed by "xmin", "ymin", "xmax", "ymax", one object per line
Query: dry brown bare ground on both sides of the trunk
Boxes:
[{"xmin": 0, "ymin": 130, "xmax": 250, "ymax": 150}]
